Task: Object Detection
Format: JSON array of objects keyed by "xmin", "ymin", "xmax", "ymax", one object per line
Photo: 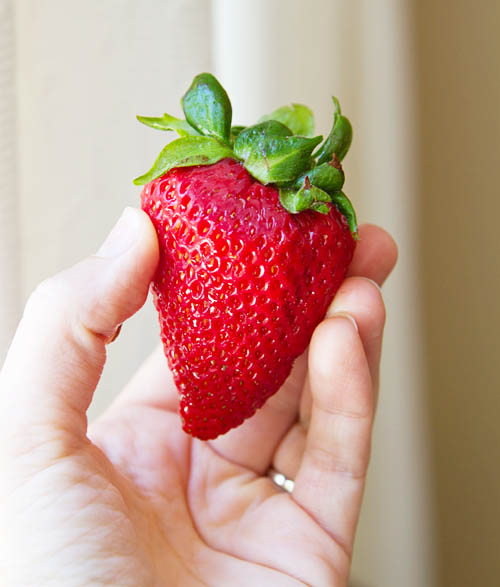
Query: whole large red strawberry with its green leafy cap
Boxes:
[{"xmin": 135, "ymin": 74, "xmax": 357, "ymax": 439}]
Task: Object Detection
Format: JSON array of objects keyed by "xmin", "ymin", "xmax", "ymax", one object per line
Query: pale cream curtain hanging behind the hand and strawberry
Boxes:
[{"xmin": 0, "ymin": 0, "xmax": 434, "ymax": 587}]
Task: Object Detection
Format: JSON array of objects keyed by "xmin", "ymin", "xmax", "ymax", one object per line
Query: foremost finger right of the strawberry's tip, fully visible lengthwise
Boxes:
[{"xmin": 293, "ymin": 315, "xmax": 374, "ymax": 554}]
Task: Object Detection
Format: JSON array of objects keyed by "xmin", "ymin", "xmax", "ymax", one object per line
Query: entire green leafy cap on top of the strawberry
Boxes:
[{"xmin": 134, "ymin": 73, "xmax": 358, "ymax": 239}]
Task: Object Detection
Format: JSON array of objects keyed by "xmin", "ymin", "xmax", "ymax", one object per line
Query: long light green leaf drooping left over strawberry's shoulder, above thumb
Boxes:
[{"xmin": 134, "ymin": 136, "xmax": 234, "ymax": 185}]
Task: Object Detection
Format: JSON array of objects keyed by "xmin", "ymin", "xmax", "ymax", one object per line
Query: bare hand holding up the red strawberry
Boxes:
[{"xmin": 0, "ymin": 209, "xmax": 396, "ymax": 587}]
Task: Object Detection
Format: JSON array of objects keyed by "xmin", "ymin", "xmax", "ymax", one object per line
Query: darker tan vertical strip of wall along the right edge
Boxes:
[{"xmin": 414, "ymin": 0, "xmax": 500, "ymax": 587}]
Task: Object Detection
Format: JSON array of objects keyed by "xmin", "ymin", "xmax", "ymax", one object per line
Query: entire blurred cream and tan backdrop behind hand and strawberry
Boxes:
[{"xmin": 0, "ymin": 0, "xmax": 500, "ymax": 587}]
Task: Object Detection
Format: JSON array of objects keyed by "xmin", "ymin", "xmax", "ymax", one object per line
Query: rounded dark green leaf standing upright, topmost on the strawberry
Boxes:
[{"xmin": 182, "ymin": 73, "xmax": 232, "ymax": 143}]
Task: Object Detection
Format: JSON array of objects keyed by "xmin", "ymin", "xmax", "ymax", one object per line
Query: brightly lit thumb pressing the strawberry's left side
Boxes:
[{"xmin": 0, "ymin": 208, "xmax": 158, "ymax": 450}]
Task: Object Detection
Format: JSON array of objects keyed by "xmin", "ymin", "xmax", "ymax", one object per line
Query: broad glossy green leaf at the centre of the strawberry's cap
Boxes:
[{"xmin": 234, "ymin": 120, "xmax": 322, "ymax": 184}]
